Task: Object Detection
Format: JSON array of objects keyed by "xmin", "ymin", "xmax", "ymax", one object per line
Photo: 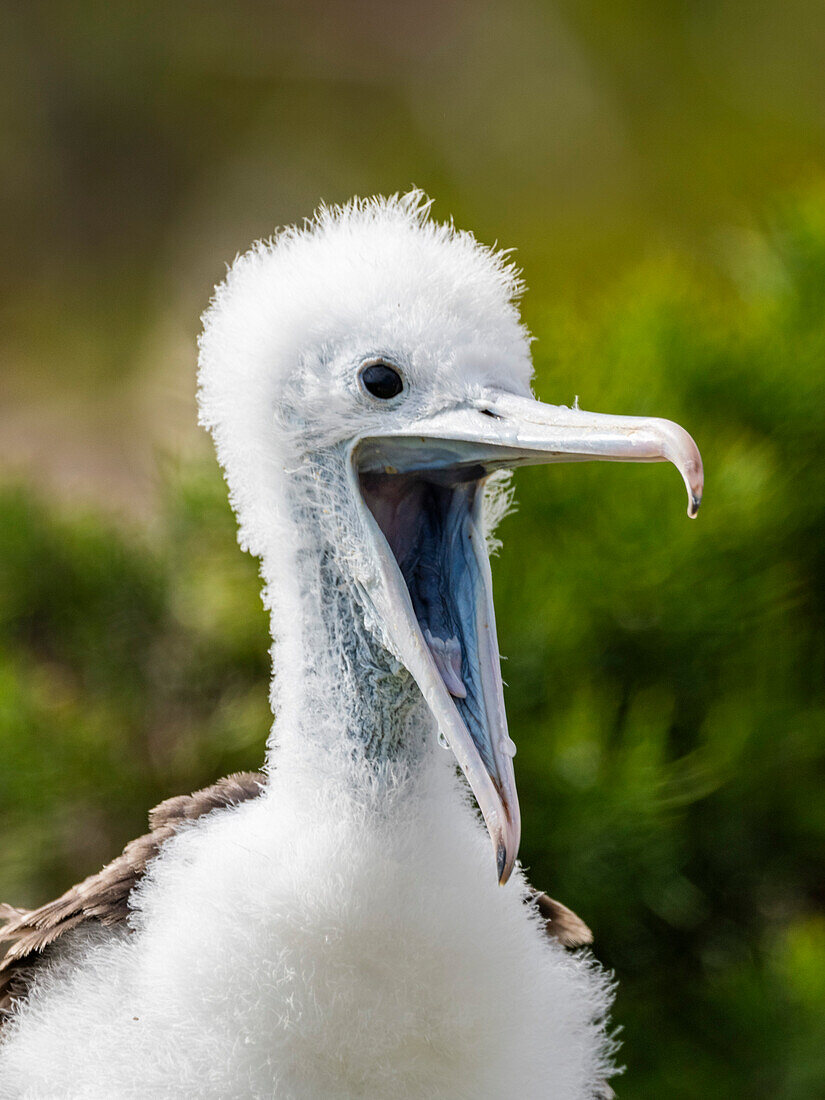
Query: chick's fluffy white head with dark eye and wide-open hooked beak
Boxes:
[{"xmin": 199, "ymin": 191, "xmax": 702, "ymax": 883}]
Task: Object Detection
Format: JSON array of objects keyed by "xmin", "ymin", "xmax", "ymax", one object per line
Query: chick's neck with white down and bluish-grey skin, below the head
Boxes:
[{"xmin": 263, "ymin": 452, "xmax": 436, "ymax": 784}]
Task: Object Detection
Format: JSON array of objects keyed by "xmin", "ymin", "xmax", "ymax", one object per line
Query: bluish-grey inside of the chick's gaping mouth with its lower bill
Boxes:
[{"xmin": 359, "ymin": 455, "xmax": 520, "ymax": 858}]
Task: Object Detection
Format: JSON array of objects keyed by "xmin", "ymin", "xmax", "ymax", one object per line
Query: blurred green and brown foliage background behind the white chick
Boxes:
[{"xmin": 0, "ymin": 0, "xmax": 825, "ymax": 1100}]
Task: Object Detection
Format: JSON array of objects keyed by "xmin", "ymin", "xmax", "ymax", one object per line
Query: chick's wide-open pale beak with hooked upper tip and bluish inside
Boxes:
[{"xmin": 351, "ymin": 391, "xmax": 703, "ymax": 884}]
